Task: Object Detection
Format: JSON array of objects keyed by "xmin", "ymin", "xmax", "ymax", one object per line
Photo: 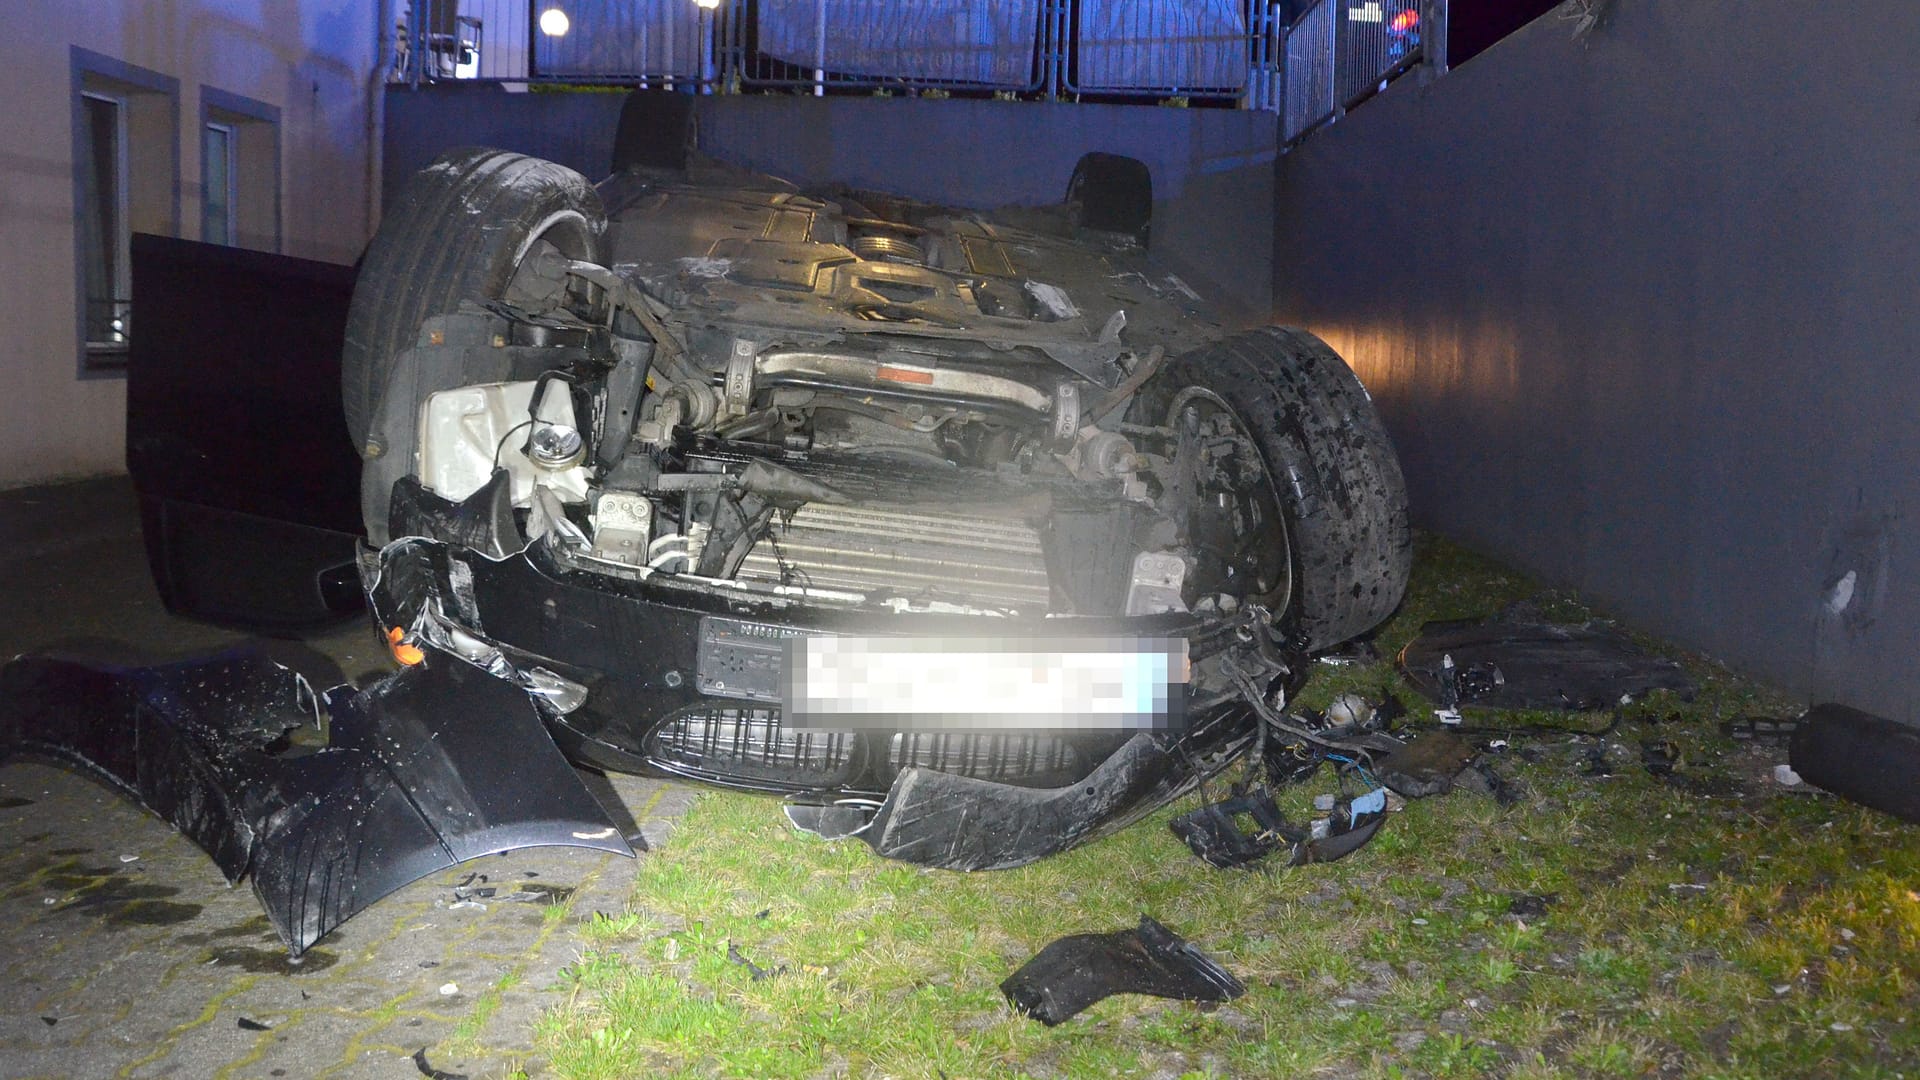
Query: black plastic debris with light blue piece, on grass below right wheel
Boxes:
[{"xmin": 1167, "ymin": 788, "xmax": 1386, "ymax": 871}]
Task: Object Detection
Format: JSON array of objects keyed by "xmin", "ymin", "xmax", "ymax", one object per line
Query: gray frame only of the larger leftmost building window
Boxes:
[{"xmin": 67, "ymin": 44, "xmax": 180, "ymax": 379}]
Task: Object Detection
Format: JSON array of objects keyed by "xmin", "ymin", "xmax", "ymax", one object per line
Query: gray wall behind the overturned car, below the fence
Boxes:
[{"xmin": 384, "ymin": 85, "xmax": 1275, "ymax": 315}]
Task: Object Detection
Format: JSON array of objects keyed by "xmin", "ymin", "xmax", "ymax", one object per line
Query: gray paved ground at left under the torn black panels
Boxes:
[{"xmin": 0, "ymin": 479, "xmax": 695, "ymax": 1080}]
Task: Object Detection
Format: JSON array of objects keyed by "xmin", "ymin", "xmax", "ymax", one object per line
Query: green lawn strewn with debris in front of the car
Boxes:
[{"xmin": 526, "ymin": 538, "xmax": 1920, "ymax": 1078}]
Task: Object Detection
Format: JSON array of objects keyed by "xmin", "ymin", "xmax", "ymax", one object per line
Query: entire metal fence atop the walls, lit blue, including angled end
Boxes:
[{"xmin": 390, "ymin": 0, "xmax": 1446, "ymax": 118}]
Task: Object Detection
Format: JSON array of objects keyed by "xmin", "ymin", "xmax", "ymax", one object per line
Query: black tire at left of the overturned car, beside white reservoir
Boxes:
[{"xmin": 340, "ymin": 146, "xmax": 607, "ymax": 457}]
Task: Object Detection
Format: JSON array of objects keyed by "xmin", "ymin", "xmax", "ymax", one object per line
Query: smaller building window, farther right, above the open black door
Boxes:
[{"xmin": 200, "ymin": 86, "xmax": 280, "ymax": 252}]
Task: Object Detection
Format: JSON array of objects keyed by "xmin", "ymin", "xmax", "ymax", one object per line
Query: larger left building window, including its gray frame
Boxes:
[{"xmin": 71, "ymin": 46, "xmax": 180, "ymax": 379}]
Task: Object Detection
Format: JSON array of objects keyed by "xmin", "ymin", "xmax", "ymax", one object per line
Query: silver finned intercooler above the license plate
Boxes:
[{"xmin": 737, "ymin": 503, "xmax": 1048, "ymax": 611}]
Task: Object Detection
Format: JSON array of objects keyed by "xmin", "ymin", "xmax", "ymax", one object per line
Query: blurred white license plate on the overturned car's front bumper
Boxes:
[{"xmin": 781, "ymin": 636, "xmax": 1188, "ymax": 730}]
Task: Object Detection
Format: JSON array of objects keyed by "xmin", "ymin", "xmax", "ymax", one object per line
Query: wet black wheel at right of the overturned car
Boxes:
[{"xmin": 1129, "ymin": 327, "xmax": 1413, "ymax": 651}]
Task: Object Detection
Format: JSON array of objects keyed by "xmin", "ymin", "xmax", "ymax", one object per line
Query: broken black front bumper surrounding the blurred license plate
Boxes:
[{"xmin": 361, "ymin": 540, "xmax": 1304, "ymax": 871}]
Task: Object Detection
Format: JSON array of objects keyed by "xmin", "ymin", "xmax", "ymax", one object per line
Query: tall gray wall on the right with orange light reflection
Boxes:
[{"xmin": 1275, "ymin": 0, "xmax": 1920, "ymax": 719}]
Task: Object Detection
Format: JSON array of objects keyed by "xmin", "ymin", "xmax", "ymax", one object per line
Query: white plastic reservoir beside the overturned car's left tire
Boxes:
[{"xmin": 419, "ymin": 382, "xmax": 588, "ymax": 505}]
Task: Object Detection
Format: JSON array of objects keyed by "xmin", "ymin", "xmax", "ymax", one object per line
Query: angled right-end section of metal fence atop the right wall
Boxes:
[{"xmin": 1281, "ymin": 0, "xmax": 1446, "ymax": 142}]
